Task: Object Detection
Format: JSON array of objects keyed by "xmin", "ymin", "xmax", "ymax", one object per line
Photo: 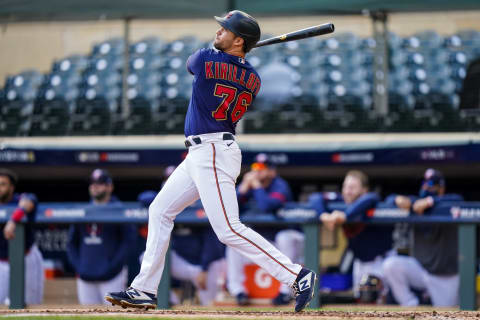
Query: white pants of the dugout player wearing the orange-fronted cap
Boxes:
[{"xmin": 226, "ymin": 230, "xmax": 305, "ymax": 296}]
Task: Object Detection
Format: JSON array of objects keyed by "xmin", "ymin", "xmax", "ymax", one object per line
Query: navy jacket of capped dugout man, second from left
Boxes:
[{"xmin": 67, "ymin": 197, "xmax": 137, "ymax": 281}]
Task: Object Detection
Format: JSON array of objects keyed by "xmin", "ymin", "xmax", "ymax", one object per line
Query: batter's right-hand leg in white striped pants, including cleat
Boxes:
[{"xmin": 186, "ymin": 142, "xmax": 316, "ymax": 311}]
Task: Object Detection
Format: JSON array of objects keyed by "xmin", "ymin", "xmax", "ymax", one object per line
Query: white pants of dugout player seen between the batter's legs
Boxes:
[{"xmin": 170, "ymin": 250, "xmax": 225, "ymax": 306}]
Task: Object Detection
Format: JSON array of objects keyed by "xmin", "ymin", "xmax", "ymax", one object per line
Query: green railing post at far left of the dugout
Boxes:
[{"xmin": 8, "ymin": 222, "xmax": 25, "ymax": 309}]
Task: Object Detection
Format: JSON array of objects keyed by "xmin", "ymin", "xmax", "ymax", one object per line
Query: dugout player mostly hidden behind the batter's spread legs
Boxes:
[{"xmin": 137, "ymin": 166, "xmax": 226, "ymax": 306}]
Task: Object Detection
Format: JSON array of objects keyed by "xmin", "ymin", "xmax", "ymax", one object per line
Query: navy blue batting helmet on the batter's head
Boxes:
[{"xmin": 215, "ymin": 10, "xmax": 260, "ymax": 52}]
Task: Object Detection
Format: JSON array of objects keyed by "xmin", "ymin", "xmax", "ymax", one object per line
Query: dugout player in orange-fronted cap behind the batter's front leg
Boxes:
[{"xmin": 226, "ymin": 153, "xmax": 303, "ymax": 306}]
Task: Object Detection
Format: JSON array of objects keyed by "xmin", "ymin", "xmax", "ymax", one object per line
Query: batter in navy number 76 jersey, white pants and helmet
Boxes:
[{"xmin": 105, "ymin": 10, "xmax": 317, "ymax": 312}]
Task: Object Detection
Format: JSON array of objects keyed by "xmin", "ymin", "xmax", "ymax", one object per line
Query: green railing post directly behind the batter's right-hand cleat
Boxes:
[{"xmin": 303, "ymin": 223, "xmax": 321, "ymax": 308}]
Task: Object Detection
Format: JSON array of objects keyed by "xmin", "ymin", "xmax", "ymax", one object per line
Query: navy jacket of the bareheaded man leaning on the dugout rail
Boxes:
[{"xmin": 310, "ymin": 192, "xmax": 393, "ymax": 262}]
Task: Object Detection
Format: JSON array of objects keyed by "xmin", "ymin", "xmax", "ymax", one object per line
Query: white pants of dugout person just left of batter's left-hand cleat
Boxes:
[{"xmin": 77, "ymin": 266, "xmax": 128, "ymax": 304}]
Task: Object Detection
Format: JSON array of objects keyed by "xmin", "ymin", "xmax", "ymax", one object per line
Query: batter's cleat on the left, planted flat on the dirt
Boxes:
[{"xmin": 105, "ymin": 287, "xmax": 157, "ymax": 310}]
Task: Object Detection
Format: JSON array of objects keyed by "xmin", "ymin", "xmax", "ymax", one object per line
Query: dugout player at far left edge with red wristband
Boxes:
[{"xmin": 0, "ymin": 168, "xmax": 44, "ymax": 305}]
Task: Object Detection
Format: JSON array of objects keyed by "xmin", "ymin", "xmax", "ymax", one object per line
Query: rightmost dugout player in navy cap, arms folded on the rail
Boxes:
[{"xmin": 383, "ymin": 169, "xmax": 463, "ymax": 307}]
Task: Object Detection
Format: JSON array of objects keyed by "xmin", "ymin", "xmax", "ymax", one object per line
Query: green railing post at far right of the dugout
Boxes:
[{"xmin": 458, "ymin": 223, "xmax": 477, "ymax": 310}]
